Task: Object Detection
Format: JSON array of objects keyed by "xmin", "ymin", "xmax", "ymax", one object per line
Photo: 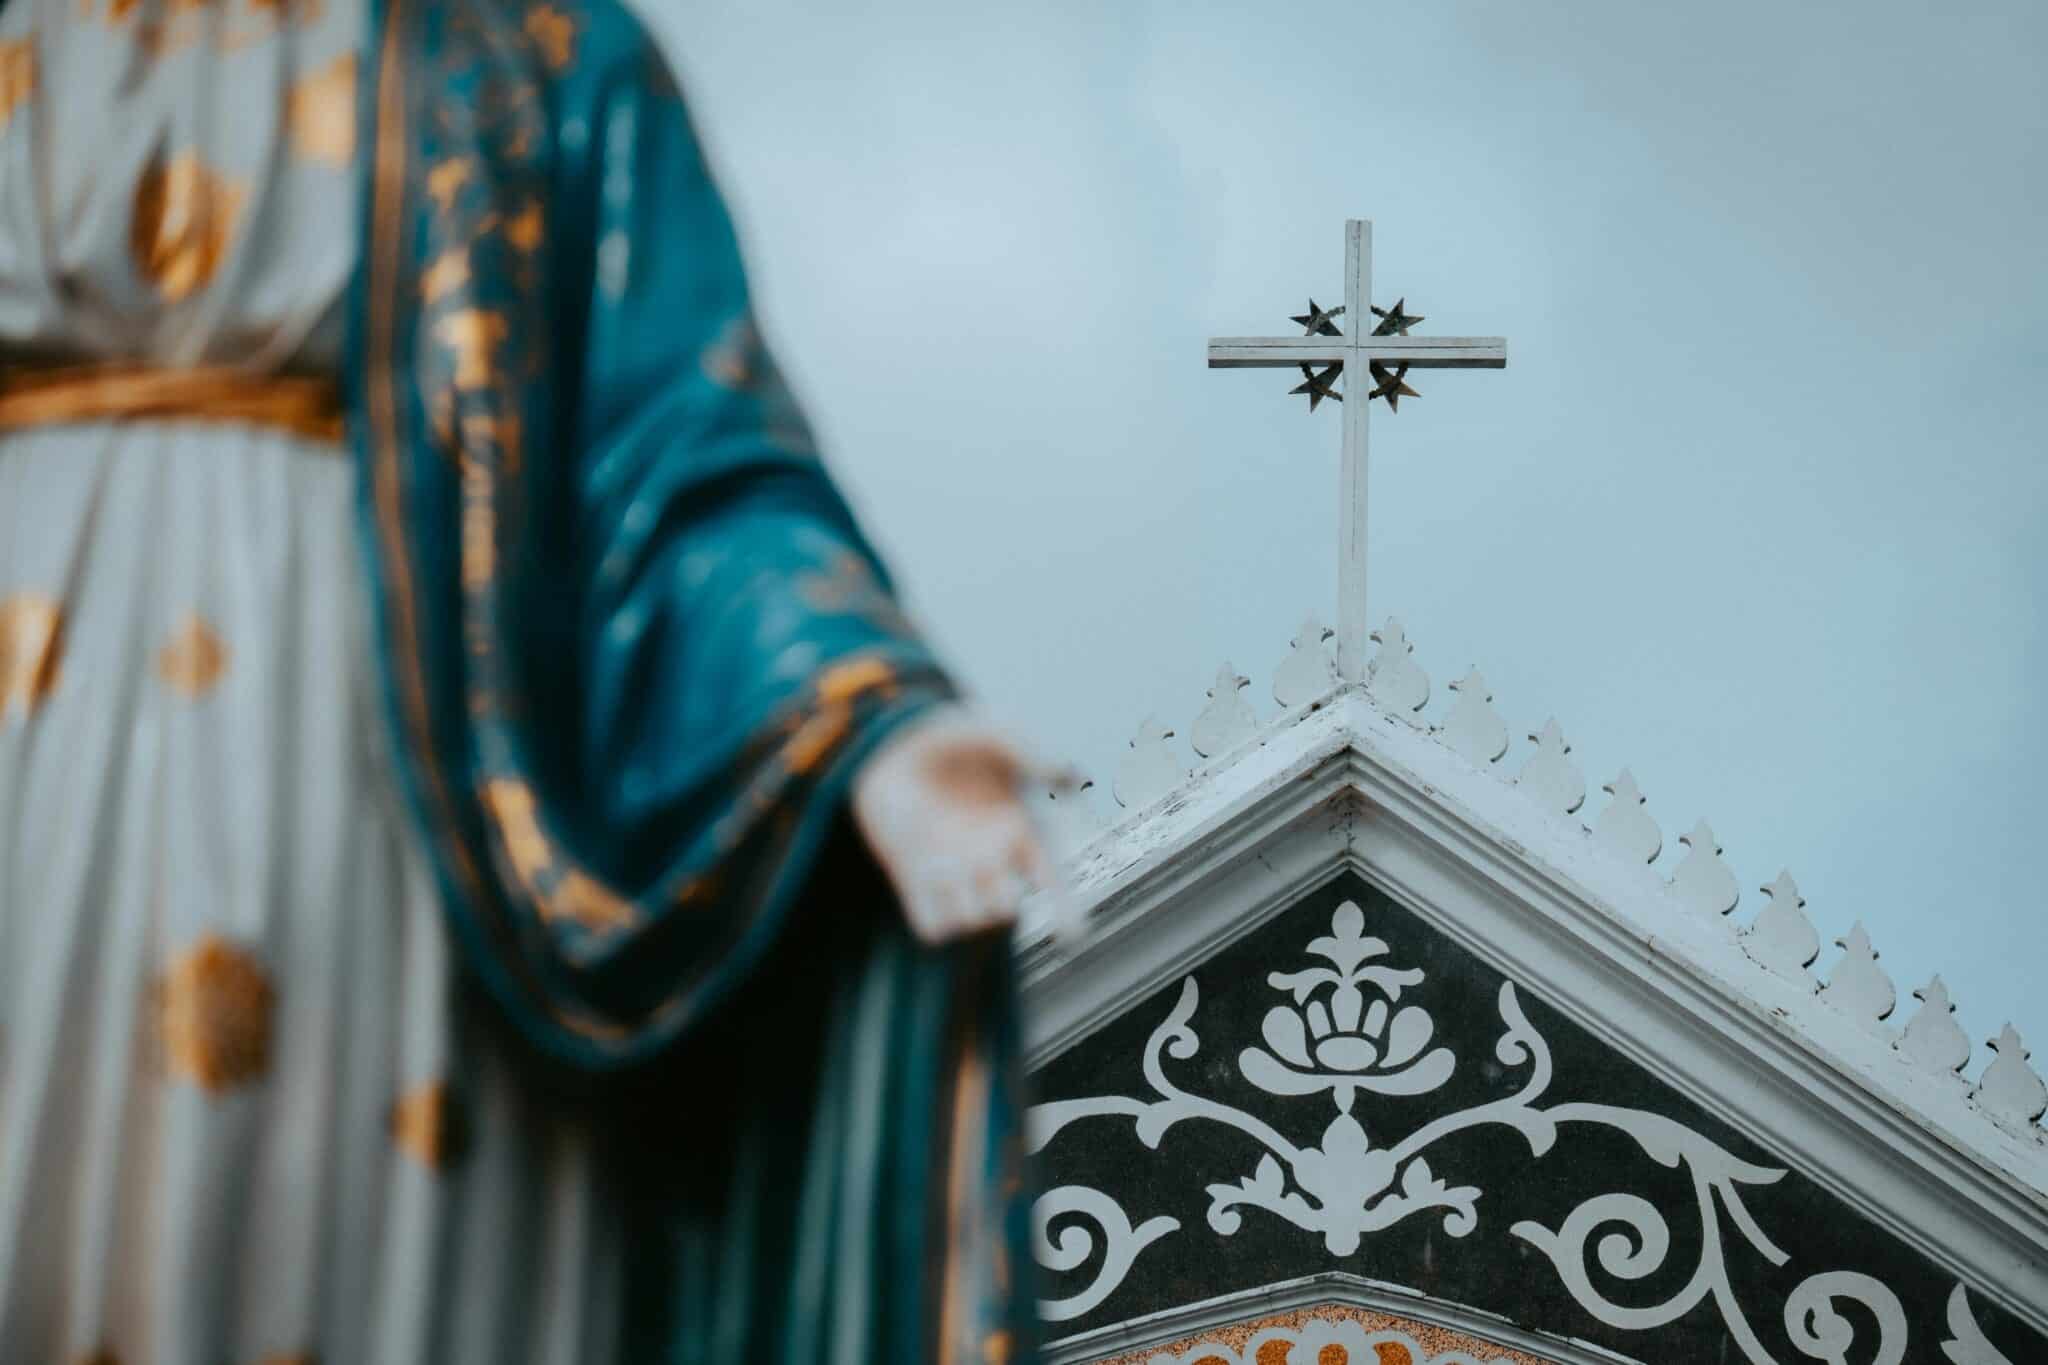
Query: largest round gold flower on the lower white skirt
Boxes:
[{"xmin": 158, "ymin": 933, "xmax": 276, "ymax": 1095}]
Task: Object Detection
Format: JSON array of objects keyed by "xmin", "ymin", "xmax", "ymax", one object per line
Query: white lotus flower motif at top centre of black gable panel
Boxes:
[{"xmin": 1237, "ymin": 900, "xmax": 1456, "ymax": 1113}]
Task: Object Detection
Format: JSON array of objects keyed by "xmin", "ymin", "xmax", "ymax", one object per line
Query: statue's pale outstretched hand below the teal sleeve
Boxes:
[{"xmin": 854, "ymin": 706, "xmax": 1055, "ymax": 943}]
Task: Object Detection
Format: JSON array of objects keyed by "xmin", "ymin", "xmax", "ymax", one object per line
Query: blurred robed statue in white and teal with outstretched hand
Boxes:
[{"xmin": 0, "ymin": 0, "xmax": 1047, "ymax": 1365}]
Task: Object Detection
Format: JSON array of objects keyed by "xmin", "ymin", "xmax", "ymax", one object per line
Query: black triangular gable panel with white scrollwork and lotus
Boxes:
[{"xmin": 1034, "ymin": 874, "xmax": 2048, "ymax": 1365}]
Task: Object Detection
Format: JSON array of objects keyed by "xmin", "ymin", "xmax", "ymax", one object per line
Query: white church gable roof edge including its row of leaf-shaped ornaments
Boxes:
[{"xmin": 1020, "ymin": 622, "xmax": 2048, "ymax": 1330}]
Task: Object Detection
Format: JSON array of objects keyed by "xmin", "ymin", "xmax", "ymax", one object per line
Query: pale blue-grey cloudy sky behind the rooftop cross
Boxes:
[{"xmin": 645, "ymin": 0, "xmax": 2048, "ymax": 1074}]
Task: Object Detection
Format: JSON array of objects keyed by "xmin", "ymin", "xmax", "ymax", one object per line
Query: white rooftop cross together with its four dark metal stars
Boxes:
[{"xmin": 1208, "ymin": 219, "xmax": 1507, "ymax": 681}]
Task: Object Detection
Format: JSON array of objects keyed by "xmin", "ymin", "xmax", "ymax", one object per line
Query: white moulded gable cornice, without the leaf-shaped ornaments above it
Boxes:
[{"xmin": 1020, "ymin": 688, "xmax": 2048, "ymax": 1330}]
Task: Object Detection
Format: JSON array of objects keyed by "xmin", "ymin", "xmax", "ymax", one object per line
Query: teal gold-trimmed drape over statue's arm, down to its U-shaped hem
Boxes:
[{"xmin": 352, "ymin": 0, "xmax": 950, "ymax": 1070}]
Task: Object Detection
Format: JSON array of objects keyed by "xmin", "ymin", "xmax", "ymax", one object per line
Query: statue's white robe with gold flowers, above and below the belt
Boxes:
[{"xmin": 0, "ymin": 0, "xmax": 623, "ymax": 1365}]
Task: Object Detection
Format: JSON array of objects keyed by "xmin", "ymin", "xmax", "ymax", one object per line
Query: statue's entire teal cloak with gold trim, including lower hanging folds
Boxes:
[{"xmin": 346, "ymin": 0, "xmax": 1032, "ymax": 1365}]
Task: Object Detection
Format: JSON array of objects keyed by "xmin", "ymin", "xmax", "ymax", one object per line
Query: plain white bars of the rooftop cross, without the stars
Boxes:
[{"xmin": 1208, "ymin": 219, "xmax": 1507, "ymax": 681}]
